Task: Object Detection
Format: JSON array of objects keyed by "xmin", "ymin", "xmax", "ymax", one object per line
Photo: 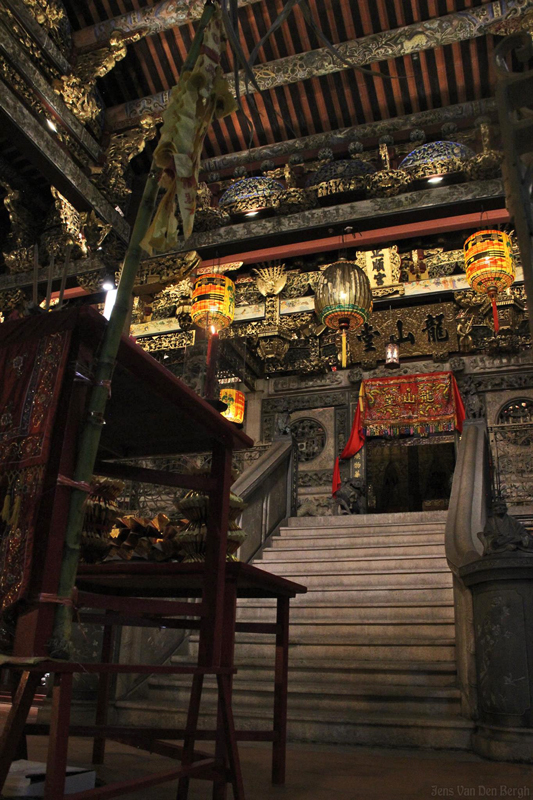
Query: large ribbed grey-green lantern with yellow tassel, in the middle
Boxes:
[{"xmin": 315, "ymin": 261, "xmax": 372, "ymax": 367}]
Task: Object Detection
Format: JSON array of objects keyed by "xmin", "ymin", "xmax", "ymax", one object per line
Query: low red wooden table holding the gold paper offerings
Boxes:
[{"xmin": 77, "ymin": 561, "xmax": 307, "ymax": 784}]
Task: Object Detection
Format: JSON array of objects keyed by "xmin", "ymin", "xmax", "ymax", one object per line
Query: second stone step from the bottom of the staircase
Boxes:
[{"xmin": 149, "ymin": 676, "xmax": 460, "ymax": 715}]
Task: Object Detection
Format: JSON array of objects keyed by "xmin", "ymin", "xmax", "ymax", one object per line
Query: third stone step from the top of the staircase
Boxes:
[{"xmin": 265, "ymin": 528, "xmax": 444, "ymax": 552}]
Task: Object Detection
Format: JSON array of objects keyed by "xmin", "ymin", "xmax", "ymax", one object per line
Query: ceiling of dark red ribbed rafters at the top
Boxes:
[{"xmin": 65, "ymin": 0, "xmax": 498, "ymax": 157}]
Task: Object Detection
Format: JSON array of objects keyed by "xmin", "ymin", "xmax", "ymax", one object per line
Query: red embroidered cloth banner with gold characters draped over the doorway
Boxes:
[{"xmin": 332, "ymin": 372, "xmax": 465, "ymax": 494}]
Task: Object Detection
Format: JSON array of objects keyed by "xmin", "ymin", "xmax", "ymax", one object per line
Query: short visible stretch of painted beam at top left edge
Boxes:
[{"xmin": 73, "ymin": 0, "xmax": 260, "ymax": 52}]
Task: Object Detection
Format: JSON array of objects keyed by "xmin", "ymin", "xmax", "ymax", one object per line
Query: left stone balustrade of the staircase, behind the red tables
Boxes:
[{"xmin": 232, "ymin": 436, "xmax": 297, "ymax": 561}]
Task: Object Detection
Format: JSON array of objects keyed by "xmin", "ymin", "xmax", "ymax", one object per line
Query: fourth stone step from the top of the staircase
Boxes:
[{"xmin": 262, "ymin": 542, "xmax": 446, "ymax": 569}]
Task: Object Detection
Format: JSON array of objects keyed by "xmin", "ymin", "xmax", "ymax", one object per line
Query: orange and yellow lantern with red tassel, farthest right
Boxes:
[{"xmin": 464, "ymin": 231, "xmax": 515, "ymax": 333}]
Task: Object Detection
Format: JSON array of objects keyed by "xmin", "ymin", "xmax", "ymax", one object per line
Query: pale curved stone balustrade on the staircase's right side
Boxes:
[{"xmin": 445, "ymin": 420, "xmax": 491, "ymax": 719}]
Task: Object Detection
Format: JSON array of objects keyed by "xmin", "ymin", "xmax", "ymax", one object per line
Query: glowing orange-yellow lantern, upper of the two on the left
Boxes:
[{"xmin": 191, "ymin": 274, "xmax": 235, "ymax": 331}]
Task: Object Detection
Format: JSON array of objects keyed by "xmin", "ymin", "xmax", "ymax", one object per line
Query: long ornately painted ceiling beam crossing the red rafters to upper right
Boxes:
[{"xmin": 106, "ymin": 0, "xmax": 533, "ymax": 130}]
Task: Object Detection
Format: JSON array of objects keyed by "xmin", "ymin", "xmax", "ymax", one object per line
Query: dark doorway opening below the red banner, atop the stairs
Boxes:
[{"xmin": 365, "ymin": 439, "xmax": 455, "ymax": 514}]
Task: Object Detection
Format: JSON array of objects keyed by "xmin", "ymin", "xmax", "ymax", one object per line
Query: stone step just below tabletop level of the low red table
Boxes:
[{"xmin": 237, "ymin": 603, "xmax": 454, "ymax": 624}]
